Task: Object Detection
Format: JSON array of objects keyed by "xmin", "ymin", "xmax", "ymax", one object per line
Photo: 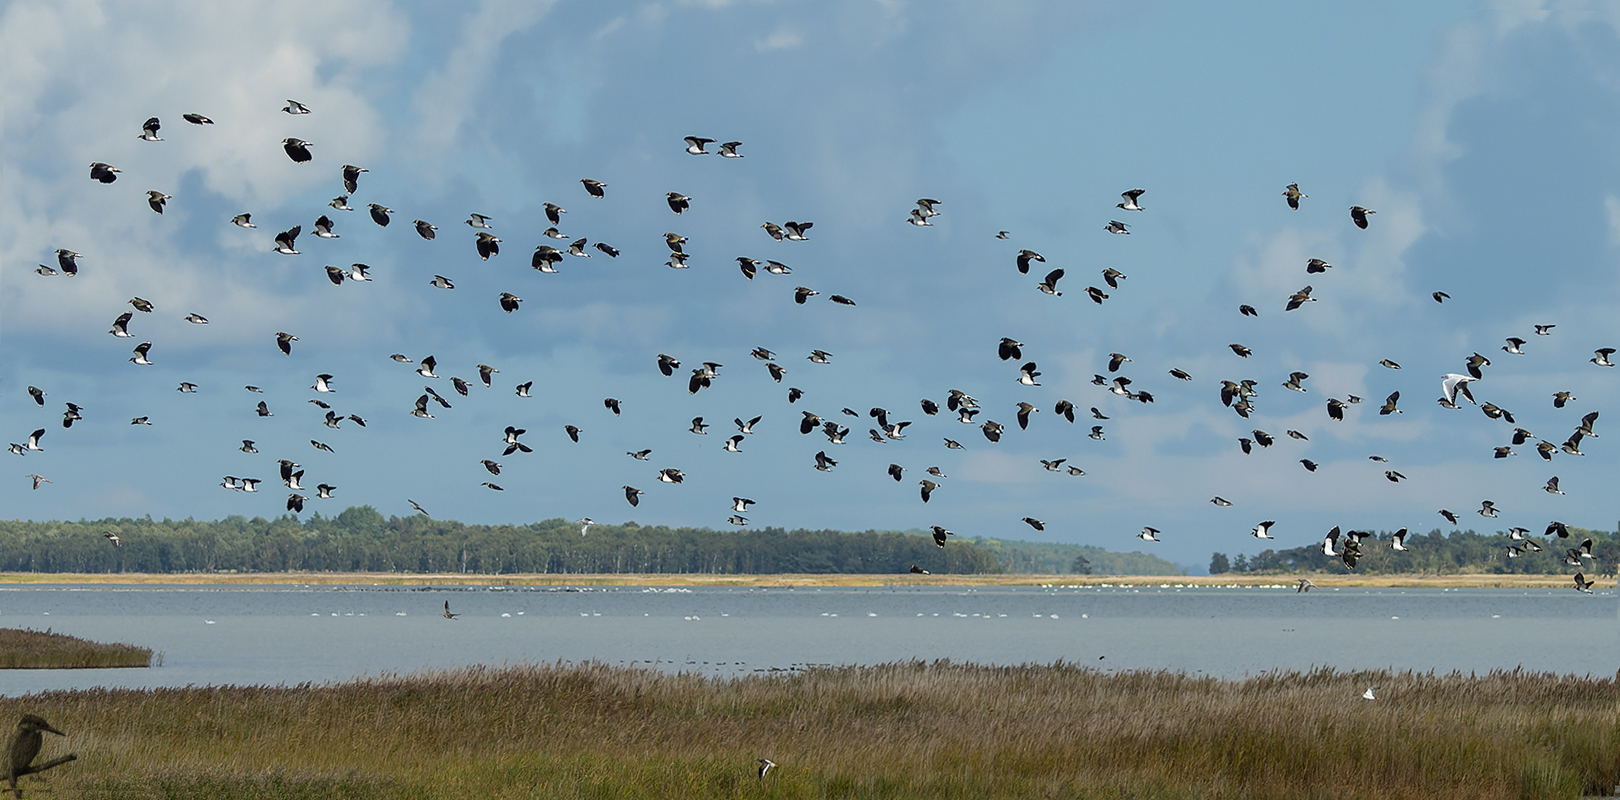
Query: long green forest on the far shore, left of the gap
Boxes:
[{"xmin": 0, "ymin": 505, "xmax": 1023, "ymax": 575}]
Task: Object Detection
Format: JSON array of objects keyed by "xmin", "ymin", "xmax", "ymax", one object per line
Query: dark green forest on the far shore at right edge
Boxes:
[{"xmin": 1210, "ymin": 528, "xmax": 1620, "ymax": 575}]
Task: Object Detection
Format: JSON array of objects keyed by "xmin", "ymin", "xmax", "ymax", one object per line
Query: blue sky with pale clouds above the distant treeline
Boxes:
[{"xmin": 0, "ymin": 0, "xmax": 1620, "ymax": 570}]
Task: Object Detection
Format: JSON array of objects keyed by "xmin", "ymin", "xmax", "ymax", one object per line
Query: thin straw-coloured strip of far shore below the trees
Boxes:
[{"xmin": 0, "ymin": 572, "xmax": 1594, "ymax": 589}]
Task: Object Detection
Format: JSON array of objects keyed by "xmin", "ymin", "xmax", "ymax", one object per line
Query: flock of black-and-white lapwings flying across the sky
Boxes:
[{"xmin": 10, "ymin": 100, "xmax": 1615, "ymax": 592}]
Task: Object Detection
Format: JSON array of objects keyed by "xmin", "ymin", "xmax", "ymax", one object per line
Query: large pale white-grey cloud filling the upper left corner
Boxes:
[{"xmin": 0, "ymin": 0, "xmax": 408, "ymax": 335}]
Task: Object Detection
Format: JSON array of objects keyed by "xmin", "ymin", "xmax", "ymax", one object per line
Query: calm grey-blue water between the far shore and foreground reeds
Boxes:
[{"xmin": 0, "ymin": 586, "xmax": 1620, "ymax": 695}]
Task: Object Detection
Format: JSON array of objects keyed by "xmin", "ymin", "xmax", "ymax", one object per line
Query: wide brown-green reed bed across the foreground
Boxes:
[{"xmin": 0, "ymin": 662, "xmax": 1620, "ymax": 800}]
